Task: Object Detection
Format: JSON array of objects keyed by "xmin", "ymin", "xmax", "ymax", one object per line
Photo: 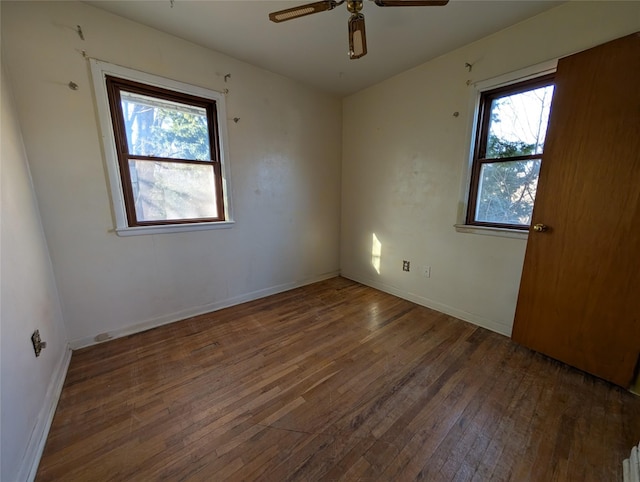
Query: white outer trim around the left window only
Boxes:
[{"xmin": 89, "ymin": 59, "xmax": 234, "ymax": 236}]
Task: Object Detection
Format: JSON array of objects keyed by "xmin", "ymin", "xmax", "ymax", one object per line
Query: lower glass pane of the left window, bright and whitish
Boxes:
[{"xmin": 129, "ymin": 159, "xmax": 218, "ymax": 221}]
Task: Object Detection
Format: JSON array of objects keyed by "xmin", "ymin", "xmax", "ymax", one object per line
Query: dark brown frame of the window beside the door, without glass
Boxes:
[{"xmin": 465, "ymin": 72, "xmax": 555, "ymax": 231}]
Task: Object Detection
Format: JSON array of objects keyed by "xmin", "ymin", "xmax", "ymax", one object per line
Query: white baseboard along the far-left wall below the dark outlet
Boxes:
[{"xmin": 18, "ymin": 345, "xmax": 71, "ymax": 482}]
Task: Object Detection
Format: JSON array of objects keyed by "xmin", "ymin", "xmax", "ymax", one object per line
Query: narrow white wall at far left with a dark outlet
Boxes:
[{"xmin": 0, "ymin": 66, "xmax": 71, "ymax": 482}]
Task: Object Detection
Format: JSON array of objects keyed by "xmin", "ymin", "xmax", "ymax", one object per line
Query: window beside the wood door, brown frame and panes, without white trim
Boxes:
[{"xmin": 466, "ymin": 74, "xmax": 554, "ymax": 230}]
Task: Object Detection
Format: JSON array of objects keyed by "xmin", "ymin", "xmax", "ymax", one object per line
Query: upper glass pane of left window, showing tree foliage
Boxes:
[{"xmin": 120, "ymin": 91, "xmax": 211, "ymax": 161}]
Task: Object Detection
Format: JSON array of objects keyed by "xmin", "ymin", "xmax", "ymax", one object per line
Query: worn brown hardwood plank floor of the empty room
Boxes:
[{"xmin": 36, "ymin": 278, "xmax": 640, "ymax": 482}]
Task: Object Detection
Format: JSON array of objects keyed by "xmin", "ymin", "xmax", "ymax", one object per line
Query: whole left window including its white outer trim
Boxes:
[{"xmin": 92, "ymin": 61, "xmax": 230, "ymax": 235}]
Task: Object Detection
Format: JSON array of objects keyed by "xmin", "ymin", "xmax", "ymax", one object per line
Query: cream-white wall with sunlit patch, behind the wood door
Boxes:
[{"xmin": 341, "ymin": 2, "xmax": 640, "ymax": 334}]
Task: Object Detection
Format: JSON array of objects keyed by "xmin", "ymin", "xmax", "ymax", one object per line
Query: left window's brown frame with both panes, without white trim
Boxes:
[{"xmin": 106, "ymin": 76, "xmax": 224, "ymax": 226}]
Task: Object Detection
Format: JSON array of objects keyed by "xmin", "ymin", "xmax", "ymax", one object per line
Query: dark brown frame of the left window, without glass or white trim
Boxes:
[{"xmin": 105, "ymin": 75, "xmax": 227, "ymax": 227}]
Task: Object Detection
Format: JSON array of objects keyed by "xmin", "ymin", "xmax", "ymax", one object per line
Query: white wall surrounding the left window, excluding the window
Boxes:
[{"xmin": 2, "ymin": 2, "xmax": 342, "ymax": 346}]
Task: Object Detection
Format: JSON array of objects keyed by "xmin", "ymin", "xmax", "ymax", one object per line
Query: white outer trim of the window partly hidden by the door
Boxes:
[{"xmin": 453, "ymin": 59, "xmax": 558, "ymax": 240}]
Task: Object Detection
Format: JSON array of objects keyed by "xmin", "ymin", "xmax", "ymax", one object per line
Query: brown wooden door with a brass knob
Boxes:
[{"xmin": 512, "ymin": 33, "xmax": 640, "ymax": 388}]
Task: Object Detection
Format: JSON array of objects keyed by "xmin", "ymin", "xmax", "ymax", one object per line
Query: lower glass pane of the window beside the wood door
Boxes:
[{"xmin": 475, "ymin": 159, "xmax": 540, "ymax": 225}]
